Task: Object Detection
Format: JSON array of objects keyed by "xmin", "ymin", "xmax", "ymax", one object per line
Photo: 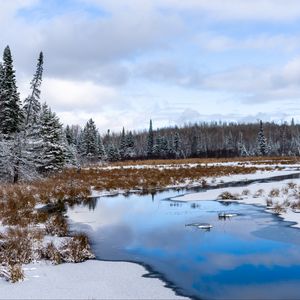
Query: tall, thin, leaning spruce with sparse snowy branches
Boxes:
[{"xmin": 24, "ymin": 52, "xmax": 44, "ymax": 126}]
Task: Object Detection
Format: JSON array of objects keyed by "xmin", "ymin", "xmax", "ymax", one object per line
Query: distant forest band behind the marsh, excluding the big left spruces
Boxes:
[{"xmin": 66, "ymin": 119, "xmax": 300, "ymax": 161}]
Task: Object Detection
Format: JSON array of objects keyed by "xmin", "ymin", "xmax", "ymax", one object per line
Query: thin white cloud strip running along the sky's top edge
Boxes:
[{"xmin": 85, "ymin": 0, "xmax": 300, "ymax": 22}]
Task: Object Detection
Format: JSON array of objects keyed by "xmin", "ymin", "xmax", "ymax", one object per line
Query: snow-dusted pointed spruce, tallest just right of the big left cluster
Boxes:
[{"xmin": 81, "ymin": 119, "xmax": 99, "ymax": 161}]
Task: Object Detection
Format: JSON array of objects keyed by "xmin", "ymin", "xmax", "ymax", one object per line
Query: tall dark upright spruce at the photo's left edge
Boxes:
[{"xmin": 0, "ymin": 46, "xmax": 24, "ymax": 135}]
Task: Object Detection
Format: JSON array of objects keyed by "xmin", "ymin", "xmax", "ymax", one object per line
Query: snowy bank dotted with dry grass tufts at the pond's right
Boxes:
[{"xmin": 172, "ymin": 179, "xmax": 300, "ymax": 228}]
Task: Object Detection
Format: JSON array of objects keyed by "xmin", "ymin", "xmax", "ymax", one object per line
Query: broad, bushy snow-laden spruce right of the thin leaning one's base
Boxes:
[{"xmin": 36, "ymin": 103, "xmax": 66, "ymax": 173}]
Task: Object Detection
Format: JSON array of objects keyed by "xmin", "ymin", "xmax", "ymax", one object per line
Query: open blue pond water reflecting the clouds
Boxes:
[{"xmin": 68, "ymin": 191, "xmax": 300, "ymax": 299}]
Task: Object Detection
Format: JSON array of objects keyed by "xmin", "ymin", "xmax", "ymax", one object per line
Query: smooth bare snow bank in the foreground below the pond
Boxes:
[{"xmin": 0, "ymin": 260, "xmax": 183, "ymax": 299}]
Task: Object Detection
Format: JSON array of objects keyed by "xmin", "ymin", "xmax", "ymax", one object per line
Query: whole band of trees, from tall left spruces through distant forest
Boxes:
[{"xmin": 0, "ymin": 46, "xmax": 300, "ymax": 182}]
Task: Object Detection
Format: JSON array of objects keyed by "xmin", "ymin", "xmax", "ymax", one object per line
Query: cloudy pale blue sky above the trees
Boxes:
[{"xmin": 0, "ymin": 0, "xmax": 300, "ymax": 132}]
